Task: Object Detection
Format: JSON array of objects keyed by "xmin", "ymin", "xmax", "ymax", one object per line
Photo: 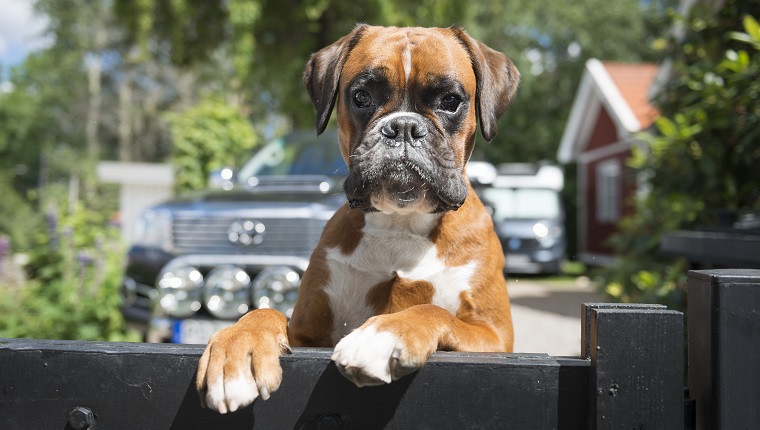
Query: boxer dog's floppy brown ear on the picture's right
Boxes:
[{"xmin": 451, "ymin": 27, "xmax": 520, "ymax": 142}]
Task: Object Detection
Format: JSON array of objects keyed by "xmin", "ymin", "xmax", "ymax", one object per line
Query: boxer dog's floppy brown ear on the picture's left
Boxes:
[{"xmin": 303, "ymin": 24, "xmax": 367, "ymax": 134}]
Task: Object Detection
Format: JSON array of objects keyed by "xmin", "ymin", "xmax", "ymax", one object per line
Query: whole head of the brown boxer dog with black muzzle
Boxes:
[{"xmin": 304, "ymin": 25, "xmax": 519, "ymax": 213}]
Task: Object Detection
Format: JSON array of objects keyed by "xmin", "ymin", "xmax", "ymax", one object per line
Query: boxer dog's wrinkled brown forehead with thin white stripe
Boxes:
[{"xmin": 340, "ymin": 27, "xmax": 477, "ymax": 95}]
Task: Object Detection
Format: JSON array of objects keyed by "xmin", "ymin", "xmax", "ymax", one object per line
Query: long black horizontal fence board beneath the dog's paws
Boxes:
[{"xmin": 0, "ymin": 339, "xmax": 588, "ymax": 429}]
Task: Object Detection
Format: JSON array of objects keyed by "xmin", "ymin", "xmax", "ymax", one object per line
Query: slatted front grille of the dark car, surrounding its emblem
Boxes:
[{"xmin": 172, "ymin": 216, "xmax": 326, "ymax": 257}]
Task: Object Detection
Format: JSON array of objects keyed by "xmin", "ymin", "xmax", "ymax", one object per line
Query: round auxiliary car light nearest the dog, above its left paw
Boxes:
[{"xmin": 253, "ymin": 266, "xmax": 301, "ymax": 318}]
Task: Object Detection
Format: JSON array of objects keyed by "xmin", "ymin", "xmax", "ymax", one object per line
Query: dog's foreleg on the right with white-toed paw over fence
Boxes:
[{"xmin": 332, "ymin": 304, "xmax": 504, "ymax": 387}]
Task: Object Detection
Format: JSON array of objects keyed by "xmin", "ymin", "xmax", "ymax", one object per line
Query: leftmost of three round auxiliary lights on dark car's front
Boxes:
[{"xmin": 158, "ymin": 266, "xmax": 203, "ymax": 317}]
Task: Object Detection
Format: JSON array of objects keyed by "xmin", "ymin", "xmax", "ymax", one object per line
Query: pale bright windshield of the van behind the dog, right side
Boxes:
[{"xmin": 483, "ymin": 188, "xmax": 560, "ymax": 222}]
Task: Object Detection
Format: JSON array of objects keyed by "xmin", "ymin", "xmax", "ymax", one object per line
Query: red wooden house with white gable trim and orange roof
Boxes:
[{"xmin": 557, "ymin": 59, "xmax": 658, "ymax": 265}]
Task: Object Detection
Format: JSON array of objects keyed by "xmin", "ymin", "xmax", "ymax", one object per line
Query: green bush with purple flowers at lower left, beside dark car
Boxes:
[{"xmin": 0, "ymin": 211, "xmax": 140, "ymax": 341}]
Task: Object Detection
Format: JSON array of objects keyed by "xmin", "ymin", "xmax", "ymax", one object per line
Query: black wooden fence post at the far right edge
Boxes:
[{"xmin": 688, "ymin": 269, "xmax": 760, "ymax": 430}]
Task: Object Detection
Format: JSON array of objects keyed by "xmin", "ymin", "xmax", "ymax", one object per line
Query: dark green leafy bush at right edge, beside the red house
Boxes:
[{"xmin": 603, "ymin": 0, "xmax": 760, "ymax": 307}]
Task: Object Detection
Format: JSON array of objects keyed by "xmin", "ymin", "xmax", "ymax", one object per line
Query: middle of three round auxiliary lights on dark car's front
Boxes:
[{"xmin": 203, "ymin": 265, "xmax": 251, "ymax": 319}]
